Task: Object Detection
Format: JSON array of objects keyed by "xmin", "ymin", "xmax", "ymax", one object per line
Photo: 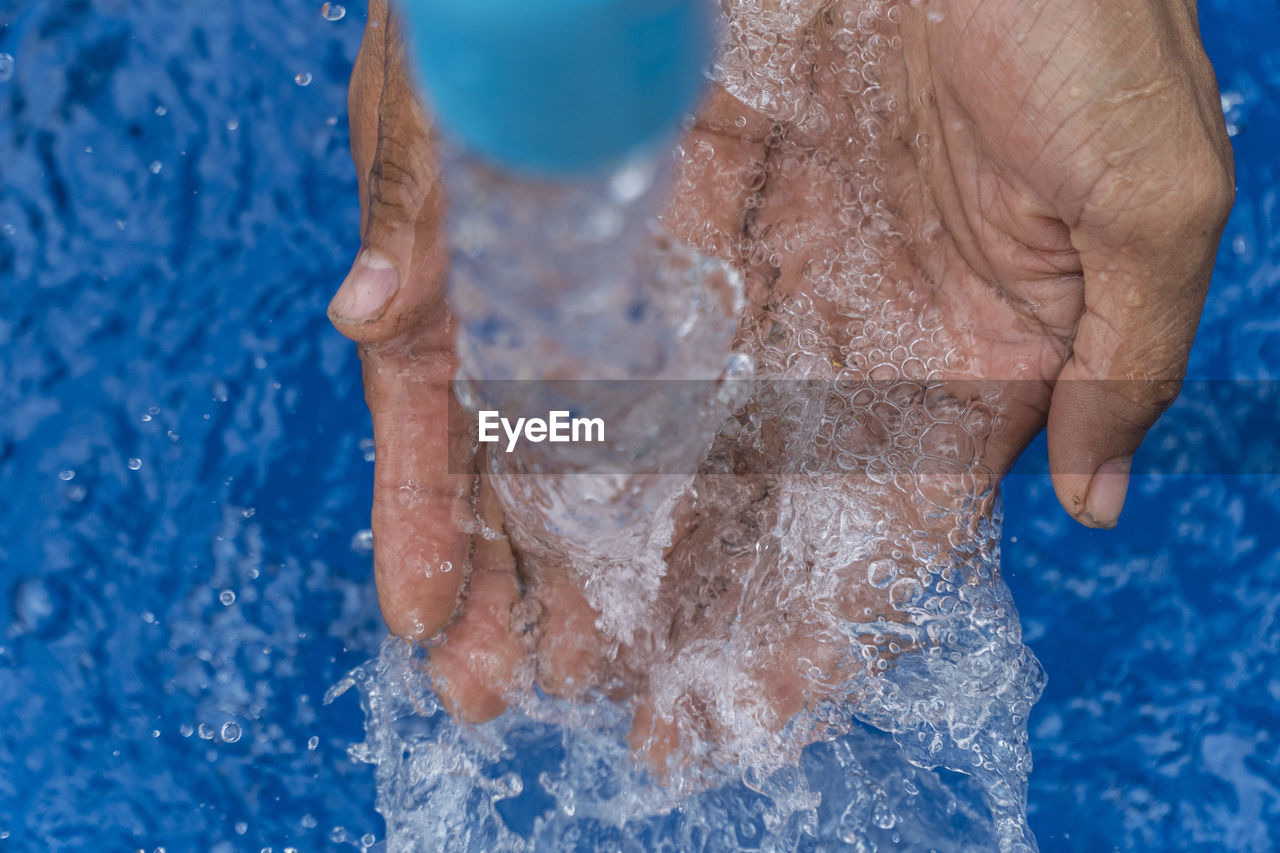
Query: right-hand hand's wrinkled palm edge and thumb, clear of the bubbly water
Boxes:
[{"xmin": 901, "ymin": 0, "xmax": 1235, "ymax": 528}]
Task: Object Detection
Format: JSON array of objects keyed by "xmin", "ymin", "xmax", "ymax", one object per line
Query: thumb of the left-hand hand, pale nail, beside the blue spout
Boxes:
[{"xmin": 329, "ymin": 4, "xmax": 448, "ymax": 343}]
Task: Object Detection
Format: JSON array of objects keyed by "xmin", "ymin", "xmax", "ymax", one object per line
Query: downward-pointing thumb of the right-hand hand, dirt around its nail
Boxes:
[{"xmin": 1048, "ymin": 145, "xmax": 1234, "ymax": 528}]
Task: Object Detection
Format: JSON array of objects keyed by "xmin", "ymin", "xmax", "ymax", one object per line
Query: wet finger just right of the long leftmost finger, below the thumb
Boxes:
[{"xmin": 430, "ymin": 473, "xmax": 525, "ymax": 722}]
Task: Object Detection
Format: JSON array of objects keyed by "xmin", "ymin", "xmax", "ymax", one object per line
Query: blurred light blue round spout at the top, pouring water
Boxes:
[{"xmin": 402, "ymin": 0, "xmax": 712, "ymax": 178}]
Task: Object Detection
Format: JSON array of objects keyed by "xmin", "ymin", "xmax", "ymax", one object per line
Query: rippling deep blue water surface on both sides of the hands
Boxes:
[{"xmin": 0, "ymin": 0, "xmax": 1280, "ymax": 853}]
